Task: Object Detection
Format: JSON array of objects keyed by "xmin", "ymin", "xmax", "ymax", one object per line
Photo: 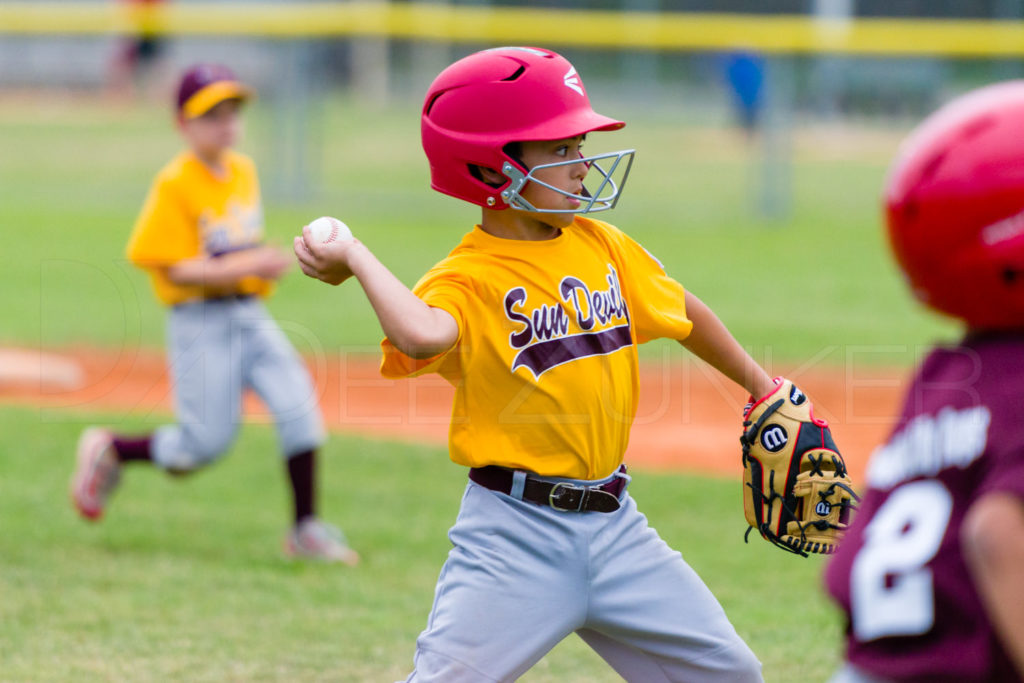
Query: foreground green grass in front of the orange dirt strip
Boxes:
[{"xmin": 0, "ymin": 408, "xmax": 840, "ymax": 683}]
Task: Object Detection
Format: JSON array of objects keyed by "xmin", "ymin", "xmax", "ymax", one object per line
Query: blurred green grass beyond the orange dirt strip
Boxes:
[{"xmin": 0, "ymin": 98, "xmax": 954, "ymax": 365}]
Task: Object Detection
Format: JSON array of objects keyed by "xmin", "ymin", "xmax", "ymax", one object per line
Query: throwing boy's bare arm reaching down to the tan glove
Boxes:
[{"xmin": 679, "ymin": 292, "xmax": 775, "ymax": 397}]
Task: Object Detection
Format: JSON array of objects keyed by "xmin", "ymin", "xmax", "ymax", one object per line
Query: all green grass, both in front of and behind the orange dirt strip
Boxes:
[{"xmin": 0, "ymin": 93, "xmax": 954, "ymax": 682}]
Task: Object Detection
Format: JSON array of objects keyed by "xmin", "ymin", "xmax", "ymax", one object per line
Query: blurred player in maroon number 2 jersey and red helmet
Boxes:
[{"xmin": 825, "ymin": 81, "xmax": 1024, "ymax": 683}]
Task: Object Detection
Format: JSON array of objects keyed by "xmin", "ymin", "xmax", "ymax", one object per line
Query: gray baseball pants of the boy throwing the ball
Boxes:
[{"xmin": 407, "ymin": 479, "xmax": 762, "ymax": 683}]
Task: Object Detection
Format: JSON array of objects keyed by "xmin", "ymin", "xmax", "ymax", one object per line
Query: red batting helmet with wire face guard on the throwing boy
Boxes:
[{"xmin": 421, "ymin": 47, "xmax": 633, "ymax": 213}]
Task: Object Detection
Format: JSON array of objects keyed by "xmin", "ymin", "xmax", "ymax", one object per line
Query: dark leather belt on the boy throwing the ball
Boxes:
[{"xmin": 469, "ymin": 465, "xmax": 628, "ymax": 512}]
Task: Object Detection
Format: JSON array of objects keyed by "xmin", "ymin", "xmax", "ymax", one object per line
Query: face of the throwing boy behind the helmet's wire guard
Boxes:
[{"xmin": 519, "ymin": 135, "xmax": 589, "ymax": 218}]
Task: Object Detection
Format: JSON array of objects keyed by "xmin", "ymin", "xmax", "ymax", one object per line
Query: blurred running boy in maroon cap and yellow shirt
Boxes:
[{"xmin": 72, "ymin": 65, "xmax": 357, "ymax": 564}]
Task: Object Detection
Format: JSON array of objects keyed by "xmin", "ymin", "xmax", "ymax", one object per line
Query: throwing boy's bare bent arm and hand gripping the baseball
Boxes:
[{"xmin": 294, "ymin": 228, "xmax": 459, "ymax": 359}]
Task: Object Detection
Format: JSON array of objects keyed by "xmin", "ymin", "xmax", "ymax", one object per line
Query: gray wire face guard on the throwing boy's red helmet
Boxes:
[{"xmin": 501, "ymin": 150, "xmax": 636, "ymax": 213}]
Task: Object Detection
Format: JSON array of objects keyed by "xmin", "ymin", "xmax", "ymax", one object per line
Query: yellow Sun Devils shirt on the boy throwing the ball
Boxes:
[{"xmin": 381, "ymin": 216, "xmax": 692, "ymax": 479}]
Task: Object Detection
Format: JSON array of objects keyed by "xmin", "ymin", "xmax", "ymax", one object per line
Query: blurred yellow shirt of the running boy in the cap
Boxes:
[{"xmin": 127, "ymin": 152, "xmax": 271, "ymax": 305}]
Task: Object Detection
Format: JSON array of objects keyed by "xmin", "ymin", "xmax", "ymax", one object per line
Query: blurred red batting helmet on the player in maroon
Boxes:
[{"xmin": 886, "ymin": 81, "xmax": 1024, "ymax": 329}]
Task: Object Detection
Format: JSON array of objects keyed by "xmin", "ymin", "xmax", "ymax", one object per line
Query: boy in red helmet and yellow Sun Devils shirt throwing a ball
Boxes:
[{"xmin": 295, "ymin": 47, "xmax": 790, "ymax": 683}]
